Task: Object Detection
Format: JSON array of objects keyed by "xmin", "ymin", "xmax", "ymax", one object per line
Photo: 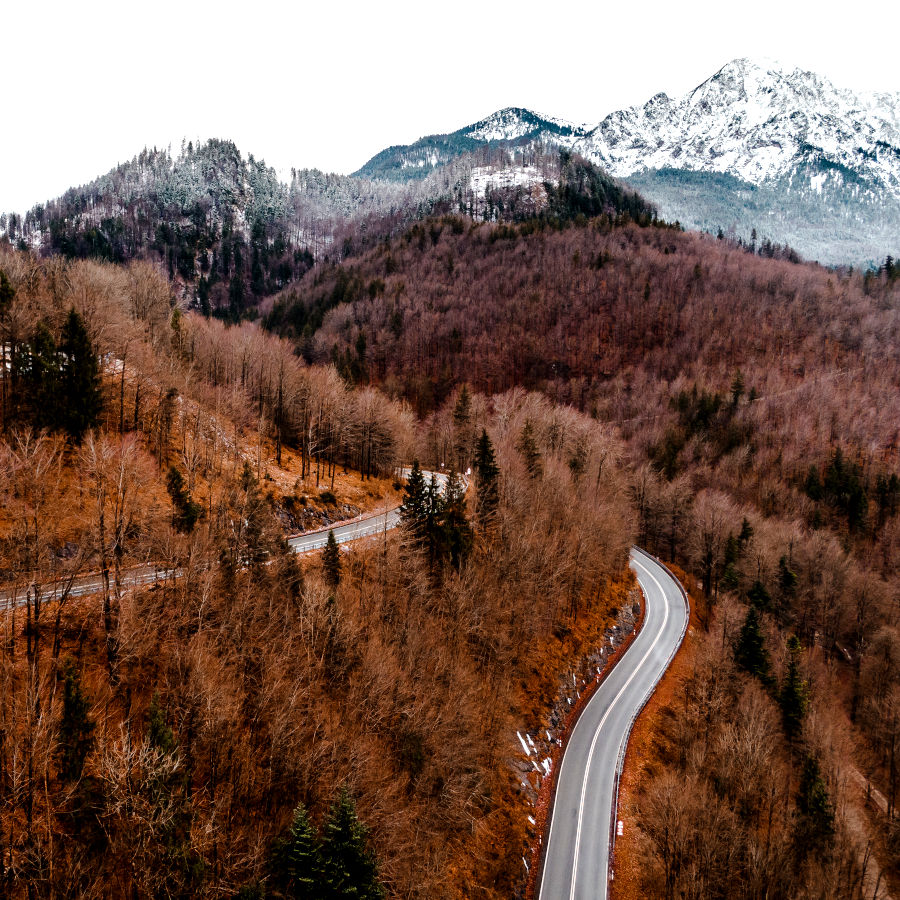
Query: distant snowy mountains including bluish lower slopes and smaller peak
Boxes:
[{"xmin": 358, "ymin": 59, "xmax": 900, "ymax": 265}]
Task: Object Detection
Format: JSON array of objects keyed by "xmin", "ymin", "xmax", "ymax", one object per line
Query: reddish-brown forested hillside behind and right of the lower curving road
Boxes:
[{"xmin": 267, "ymin": 216, "xmax": 900, "ymax": 897}]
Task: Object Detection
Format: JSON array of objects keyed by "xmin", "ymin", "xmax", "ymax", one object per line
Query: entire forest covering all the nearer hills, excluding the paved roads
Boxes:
[{"xmin": 0, "ymin": 153, "xmax": 900, "ymax": 900}]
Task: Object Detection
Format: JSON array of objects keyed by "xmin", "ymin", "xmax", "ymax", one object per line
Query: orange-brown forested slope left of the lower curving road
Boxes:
[{"xmin": 0, "ymin": 248, "xmax": 636, "ymax": 900}]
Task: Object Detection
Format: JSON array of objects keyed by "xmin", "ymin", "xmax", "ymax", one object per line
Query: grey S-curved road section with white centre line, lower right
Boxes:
[{"xmin": 538, "ymin": 548, "xmax": 688, "ymax": 900}]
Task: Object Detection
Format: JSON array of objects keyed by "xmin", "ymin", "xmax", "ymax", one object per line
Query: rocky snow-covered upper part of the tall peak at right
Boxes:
[{"xmin": 575, "ymin": 59, "xmax": 900, "ymax": 198}]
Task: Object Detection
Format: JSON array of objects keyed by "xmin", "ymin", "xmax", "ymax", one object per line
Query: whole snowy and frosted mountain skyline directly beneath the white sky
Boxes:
[{"xmin": 7, "ymin": 58, "xmax": 900, "ymax": 266}]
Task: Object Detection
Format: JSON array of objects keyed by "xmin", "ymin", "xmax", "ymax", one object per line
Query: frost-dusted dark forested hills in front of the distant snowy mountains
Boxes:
[{"xmin": 0, "ymin": 148, "xmax": 654, "ymax": 322}]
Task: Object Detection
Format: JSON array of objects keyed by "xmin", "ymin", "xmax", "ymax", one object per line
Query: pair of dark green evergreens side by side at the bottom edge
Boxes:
[{"xmin": 267, "ymin": 789, "xmax": 385, "ymax": 900}]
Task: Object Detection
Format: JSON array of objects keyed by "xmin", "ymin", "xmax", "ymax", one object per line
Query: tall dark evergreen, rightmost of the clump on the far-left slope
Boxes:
[{"xmin": 59, "ymin": 308, "xmax": 103, "ymax": 443}]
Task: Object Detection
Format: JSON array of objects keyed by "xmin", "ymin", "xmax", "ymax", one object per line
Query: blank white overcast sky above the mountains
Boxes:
[{"xmin": 0, "ymin": 0, "xmax": 900, "ymax": 212}]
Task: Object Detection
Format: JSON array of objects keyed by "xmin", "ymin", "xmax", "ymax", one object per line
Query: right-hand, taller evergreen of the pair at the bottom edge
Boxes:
[{"xmin": 322, "ymin": 789, "xmax": 385, "ymax": 900}]
